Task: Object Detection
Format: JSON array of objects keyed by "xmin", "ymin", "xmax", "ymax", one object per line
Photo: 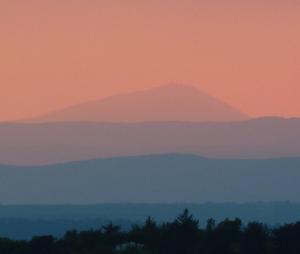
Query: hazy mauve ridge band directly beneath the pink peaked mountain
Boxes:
[{"xmin": 0, "ymin": 118, "xmax": 300, "ymax": 166}]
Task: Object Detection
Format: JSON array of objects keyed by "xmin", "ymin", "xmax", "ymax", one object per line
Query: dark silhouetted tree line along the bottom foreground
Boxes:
[{"xmin": 0, "ymin": 210, "xmax": 300, "ymax": 254}]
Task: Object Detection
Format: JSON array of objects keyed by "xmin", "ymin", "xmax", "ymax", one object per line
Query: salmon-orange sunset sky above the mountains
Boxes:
[{"xmin": 0, "ymin": 0, "xmax": 300, "ymax": 121}]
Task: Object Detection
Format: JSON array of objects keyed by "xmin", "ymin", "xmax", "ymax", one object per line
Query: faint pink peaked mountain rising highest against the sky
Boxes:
[{"xmin": 28, "ymin": 85, "xmax": 248, "ymax": 122}]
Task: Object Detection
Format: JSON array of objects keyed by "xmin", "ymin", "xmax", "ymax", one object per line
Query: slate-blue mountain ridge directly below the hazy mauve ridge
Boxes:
[{"xmin": 0, "ymin": 154, "xmax": 300, "ymax": 204}]
